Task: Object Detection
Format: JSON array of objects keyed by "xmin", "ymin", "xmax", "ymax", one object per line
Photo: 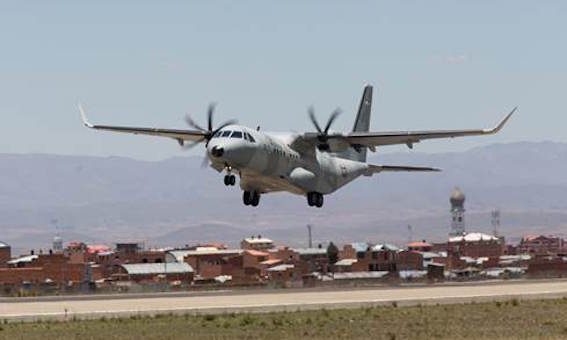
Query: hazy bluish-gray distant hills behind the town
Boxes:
[{"xmin": 0, "ymin": 142, "xmax": 567, "ymax": 249}]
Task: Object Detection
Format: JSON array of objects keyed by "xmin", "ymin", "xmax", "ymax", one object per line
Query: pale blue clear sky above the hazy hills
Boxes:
[{"xmin": 0, "ymin": 1, "xmax": 567, "ymax": 159}]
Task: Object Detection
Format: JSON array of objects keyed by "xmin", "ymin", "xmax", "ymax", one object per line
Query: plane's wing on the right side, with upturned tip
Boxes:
[{"xmin": 294, "ymin": 107, "xmax": 517, "ymax": 151}]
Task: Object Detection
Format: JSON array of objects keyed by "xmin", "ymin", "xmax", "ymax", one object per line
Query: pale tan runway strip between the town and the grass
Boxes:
[{"xmin": 0, "ymin": 280, "xmax": 567, "ymax": 321}]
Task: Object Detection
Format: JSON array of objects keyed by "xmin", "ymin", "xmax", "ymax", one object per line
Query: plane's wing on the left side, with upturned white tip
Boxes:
[{"xmin": 79, "ymin": 105, "xmax": 205, "ymax": 145}]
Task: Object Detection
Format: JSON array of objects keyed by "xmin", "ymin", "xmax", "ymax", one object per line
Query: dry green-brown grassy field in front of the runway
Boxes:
[{"xmin": 0, "ymin": 298, "xmax": 567, "ymax": 340}]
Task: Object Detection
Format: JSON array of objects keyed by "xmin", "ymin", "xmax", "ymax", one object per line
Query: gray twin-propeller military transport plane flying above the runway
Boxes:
[{"xmin": 79, "ymin": 85, "xmax": 516, "ymax": 208}]
